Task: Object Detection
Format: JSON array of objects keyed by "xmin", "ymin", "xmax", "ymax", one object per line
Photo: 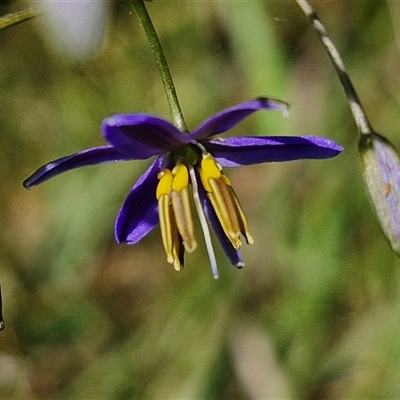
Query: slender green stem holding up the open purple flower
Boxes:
[{"xmin": 132, "ymin": 1, "xmax": 188, "ymax": 132}]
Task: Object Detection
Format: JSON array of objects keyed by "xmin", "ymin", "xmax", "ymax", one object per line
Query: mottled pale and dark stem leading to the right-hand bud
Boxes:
[{"xmin": 296, "ymin": 0, "xmax": 373, "ymax": 135}]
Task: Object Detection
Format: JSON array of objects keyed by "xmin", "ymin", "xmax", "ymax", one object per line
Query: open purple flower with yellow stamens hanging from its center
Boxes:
[{"xmin": 24, "ymin": 98, "xmax": 343, "ymax": 278}]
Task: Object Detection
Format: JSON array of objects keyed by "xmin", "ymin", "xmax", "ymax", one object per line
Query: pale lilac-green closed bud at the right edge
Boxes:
[{"xmin": 359, "ymin": 133, "xmax": 400, "ymax": 256}]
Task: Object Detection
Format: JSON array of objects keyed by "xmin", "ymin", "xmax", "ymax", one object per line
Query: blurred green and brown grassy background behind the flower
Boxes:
[{"xmin": 0, "ymin": 0, "xmax": 400, "ymax": 399}]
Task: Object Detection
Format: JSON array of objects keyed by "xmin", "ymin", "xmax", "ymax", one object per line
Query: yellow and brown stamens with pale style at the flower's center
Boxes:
[{"xmin": 156, "ymin": 148, "xmax": 253, "ymax": 277}]
